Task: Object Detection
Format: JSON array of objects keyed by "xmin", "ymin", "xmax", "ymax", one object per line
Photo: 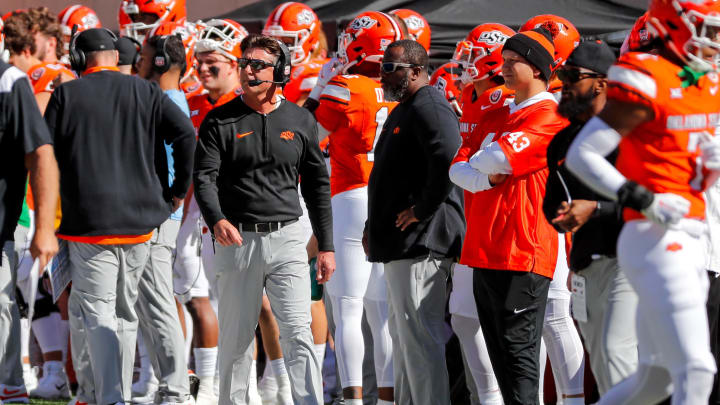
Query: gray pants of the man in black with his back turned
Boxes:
[{"xmin": 68, "ymin": 238, "xmax": 150, "ymax": 405}]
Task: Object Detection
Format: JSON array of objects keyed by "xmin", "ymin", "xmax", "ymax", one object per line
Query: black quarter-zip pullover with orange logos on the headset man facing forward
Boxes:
[{"xmin": 194, "ymin": 97, "xmax": 333, "ymax": 251}]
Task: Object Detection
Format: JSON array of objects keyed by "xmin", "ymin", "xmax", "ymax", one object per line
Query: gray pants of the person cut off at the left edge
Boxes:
[{"xmin": 0, "ymin": 241, "xmax": 25, "ymax": 386}]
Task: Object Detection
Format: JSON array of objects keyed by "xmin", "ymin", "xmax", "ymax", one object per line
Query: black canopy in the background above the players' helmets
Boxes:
[{"xmin": 221, "ymin": 0, "xmax": 645, "ymax": 62}]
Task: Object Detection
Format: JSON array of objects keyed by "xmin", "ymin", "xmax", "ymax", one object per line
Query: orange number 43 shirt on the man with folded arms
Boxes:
[{"xmin": 453, "ymin": 93, "xmax": 568, "ymax": 278}]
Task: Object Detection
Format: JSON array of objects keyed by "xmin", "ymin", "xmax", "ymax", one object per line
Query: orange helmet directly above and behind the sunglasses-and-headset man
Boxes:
[{"xmin": 262, "ymin": 2, "xmax": 320, "ymax": 65}]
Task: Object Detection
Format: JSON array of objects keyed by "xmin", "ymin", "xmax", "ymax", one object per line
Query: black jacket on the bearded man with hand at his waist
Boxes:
[{"xmin": 366, "ymin": 86, "xmax": 465, "ymax": 263}]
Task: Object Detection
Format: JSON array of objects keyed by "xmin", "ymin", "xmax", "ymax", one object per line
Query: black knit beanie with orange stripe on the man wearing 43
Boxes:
[{"xmin": 503, "ymin": 27, "xmax": 555, "ymax": 82}]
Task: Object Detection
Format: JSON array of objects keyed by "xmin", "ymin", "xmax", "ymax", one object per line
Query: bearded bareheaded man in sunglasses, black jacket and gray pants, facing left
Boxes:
[{"xmin": 363, "ymin": 40, "xmax": 465, "ymax": 405}]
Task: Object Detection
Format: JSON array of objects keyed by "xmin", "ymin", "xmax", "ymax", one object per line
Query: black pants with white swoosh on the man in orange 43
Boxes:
[{"xmin": 473, "ymin": 269, "xmax": 551, "ymax": 405}]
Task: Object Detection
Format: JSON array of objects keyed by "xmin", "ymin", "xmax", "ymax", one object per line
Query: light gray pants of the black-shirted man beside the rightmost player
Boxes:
[{"xmin": 578, "ymin": 258, "xmax": 638, "ymax": 396}]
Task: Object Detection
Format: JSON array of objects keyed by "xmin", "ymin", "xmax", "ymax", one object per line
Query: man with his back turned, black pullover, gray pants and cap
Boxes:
[{"xmin": 45, "ymin": 29, "xmax": 195, "ymax": 404}]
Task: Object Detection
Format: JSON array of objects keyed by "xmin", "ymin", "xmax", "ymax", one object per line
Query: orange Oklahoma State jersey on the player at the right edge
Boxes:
[{"xmin": 608, "ymin": 52, "xmax": 720, "ymax": 220}]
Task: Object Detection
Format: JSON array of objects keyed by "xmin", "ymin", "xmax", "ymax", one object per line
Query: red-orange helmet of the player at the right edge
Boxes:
[{"xmin": 647, "ymin": 0, "xmax": 720, "ymax": 72}]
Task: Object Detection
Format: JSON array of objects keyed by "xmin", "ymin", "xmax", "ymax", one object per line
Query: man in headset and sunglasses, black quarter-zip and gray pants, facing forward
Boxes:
[{"xmin": 194, "ymin": 35, "xmax": 335, "ymax": 405}]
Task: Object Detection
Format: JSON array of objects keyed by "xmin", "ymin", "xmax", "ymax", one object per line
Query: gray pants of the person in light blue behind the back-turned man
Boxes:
[{"xmin": 135, "ymin": 219, "xmax": 190, "ymax": 402}]
